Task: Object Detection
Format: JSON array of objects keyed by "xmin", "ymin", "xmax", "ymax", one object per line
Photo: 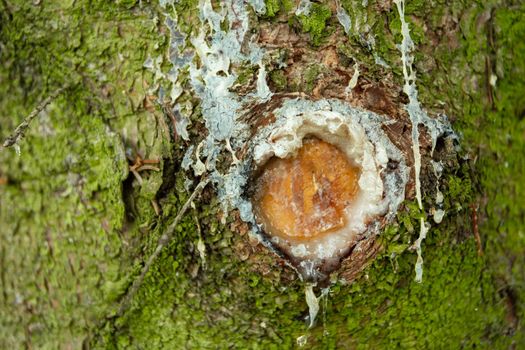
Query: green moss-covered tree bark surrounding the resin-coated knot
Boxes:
[{"xmin": 0, "ymin": 0, "xmax": 525, "ymax": 349}]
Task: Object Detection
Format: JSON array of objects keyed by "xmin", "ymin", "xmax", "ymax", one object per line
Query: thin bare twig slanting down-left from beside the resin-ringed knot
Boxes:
[{"xmin": 116, "ymin": 178, "xmax": 209, "ymax": 317}]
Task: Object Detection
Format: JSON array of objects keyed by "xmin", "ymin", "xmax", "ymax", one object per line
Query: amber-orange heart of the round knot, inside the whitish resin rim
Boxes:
[{"xmin": 253, "ymin": 138, "xmax": 359, "ymax": 240}]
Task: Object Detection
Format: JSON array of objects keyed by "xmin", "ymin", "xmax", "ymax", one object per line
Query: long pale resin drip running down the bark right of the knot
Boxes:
[{"xmin": 394, "ymin": 0, "xmax": 428, "ymax": 282}]
